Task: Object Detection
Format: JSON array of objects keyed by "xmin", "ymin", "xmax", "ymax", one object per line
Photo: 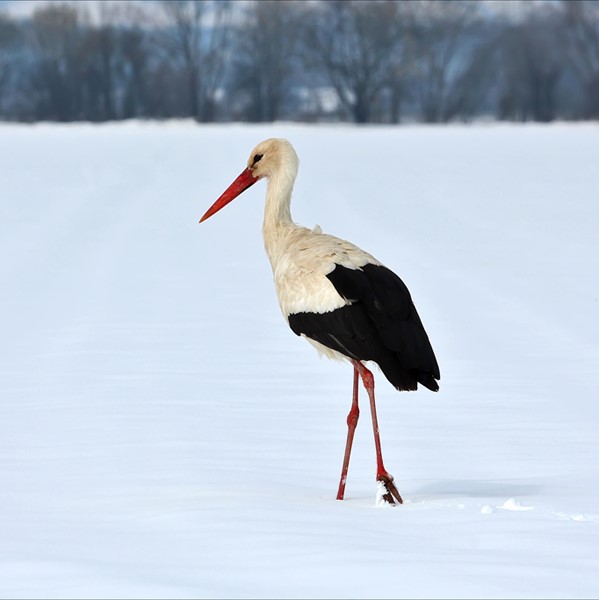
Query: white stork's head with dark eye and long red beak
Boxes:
[{"xmin": 200, "ymin": 138, "xmax": 299, "ymax": 223}]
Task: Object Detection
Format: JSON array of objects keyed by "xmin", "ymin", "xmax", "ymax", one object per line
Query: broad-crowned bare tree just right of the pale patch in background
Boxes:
[{"xmin": 305, "ymin": 0, "xmax": 402, "ymax": 123}]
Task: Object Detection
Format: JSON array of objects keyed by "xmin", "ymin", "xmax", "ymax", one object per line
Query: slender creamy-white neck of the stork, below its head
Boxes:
[{"xmin": 262, "ymin": 173, "xmax": 297, "ymax": 264}]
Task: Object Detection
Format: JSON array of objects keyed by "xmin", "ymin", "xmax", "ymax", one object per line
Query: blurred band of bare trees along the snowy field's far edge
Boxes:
[{"xmin": 0, "ymin": 0, "xmax": 599, "ymax": 123}]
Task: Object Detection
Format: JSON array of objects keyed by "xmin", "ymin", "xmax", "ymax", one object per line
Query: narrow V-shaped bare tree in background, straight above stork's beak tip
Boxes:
[{"xmin": 162, "ymin": 0, "xmax": 231, "ymax": 121}]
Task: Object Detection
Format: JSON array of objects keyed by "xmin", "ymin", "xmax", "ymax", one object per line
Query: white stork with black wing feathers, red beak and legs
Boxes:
[{"xmin": 200, "ymin": 138, "xmax": 441, "ymax": 505}]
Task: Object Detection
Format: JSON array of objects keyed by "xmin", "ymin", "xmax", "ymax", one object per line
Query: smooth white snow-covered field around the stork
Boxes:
[{"xmin": 0, "ymin": 123, "xmax": 599, "ymax": 598}]
